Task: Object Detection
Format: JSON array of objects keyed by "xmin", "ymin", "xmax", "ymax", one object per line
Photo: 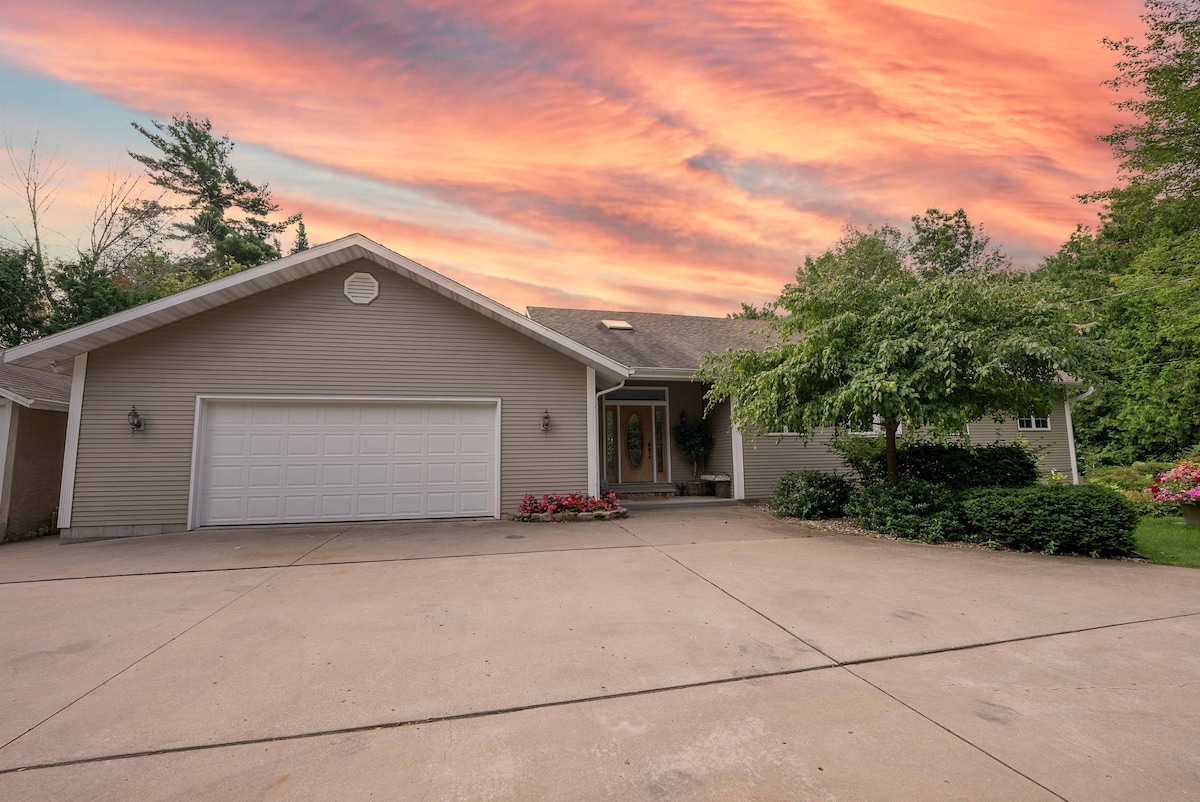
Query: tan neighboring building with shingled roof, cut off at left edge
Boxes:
[{"xmin": 0, "ymin": 363, "xmax": 71, "ymax": 543}]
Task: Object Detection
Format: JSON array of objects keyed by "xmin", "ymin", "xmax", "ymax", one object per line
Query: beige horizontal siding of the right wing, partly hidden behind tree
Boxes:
[{"xmin": 743, "ymin": 403, "xmax": 1070, "ymax": 498}]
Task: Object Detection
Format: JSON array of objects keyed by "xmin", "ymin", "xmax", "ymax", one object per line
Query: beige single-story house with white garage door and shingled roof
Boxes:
[{"xmin": 5, "ymin": 234, "xmax": 1089, "ymax": 541}]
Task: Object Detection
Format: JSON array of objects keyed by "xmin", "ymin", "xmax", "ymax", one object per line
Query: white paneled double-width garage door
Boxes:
[{"xmin": 196, "ymin": 401, "xmax": 499, "ymax": 526}]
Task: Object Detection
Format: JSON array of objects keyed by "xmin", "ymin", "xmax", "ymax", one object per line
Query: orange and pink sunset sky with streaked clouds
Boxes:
[{"xmin": 0, "ymin": 0, "xmax": 1141, "ymax": 315}]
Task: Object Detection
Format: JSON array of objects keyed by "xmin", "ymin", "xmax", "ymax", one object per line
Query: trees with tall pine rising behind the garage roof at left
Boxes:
[{"xmin": 0, "ymin": 115, "xmax": 308, "ymax": 347}]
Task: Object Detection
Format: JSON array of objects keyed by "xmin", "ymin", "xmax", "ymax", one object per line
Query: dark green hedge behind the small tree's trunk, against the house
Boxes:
[{"xmin": 834, "ymin": 437, "xmax": 1042, "ymax": 490}]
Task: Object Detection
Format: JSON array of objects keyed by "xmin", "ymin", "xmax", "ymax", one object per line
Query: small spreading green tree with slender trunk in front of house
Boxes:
[{"xmin": 697, "ymin": 222, "xmax": 1103, "ymax": 479}]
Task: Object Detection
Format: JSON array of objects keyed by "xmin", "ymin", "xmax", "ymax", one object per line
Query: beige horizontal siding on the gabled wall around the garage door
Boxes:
[{"xmin": 72, "ymin": 262, "xmax": 587, "ymax": 528}]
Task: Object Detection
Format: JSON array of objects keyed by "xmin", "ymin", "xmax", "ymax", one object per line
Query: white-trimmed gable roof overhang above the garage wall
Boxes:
[{"xmin": 4, "ymin": 234, "xmax": 629, "ymax": 377}]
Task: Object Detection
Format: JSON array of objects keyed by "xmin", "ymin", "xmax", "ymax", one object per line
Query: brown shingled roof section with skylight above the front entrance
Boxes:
[{"xmin": 528, "ymin": 306, "xmax": 768, "ymax": 378}]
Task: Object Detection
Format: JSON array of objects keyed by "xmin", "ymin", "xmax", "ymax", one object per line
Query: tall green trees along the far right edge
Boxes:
[{"xmin": 1039, "ymin": 0, "xmax": 1200, "ymax": 463}]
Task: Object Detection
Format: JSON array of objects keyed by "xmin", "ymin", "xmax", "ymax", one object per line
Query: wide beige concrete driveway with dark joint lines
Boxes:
[{"xmin": 0, "ymin": 508, "xmax": 1200, "ymax": 801}]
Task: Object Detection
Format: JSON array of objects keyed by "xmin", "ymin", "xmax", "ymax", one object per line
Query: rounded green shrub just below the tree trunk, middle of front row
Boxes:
[{"xmin": 846, "ymin": 477, "xmax": 965, "ymax": 543}]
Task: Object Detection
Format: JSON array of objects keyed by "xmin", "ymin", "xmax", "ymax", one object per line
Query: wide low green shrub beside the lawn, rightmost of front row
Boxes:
[{"xmin": 962, "ymin": 485, "xmax": 1138, "ymax": 557}]
